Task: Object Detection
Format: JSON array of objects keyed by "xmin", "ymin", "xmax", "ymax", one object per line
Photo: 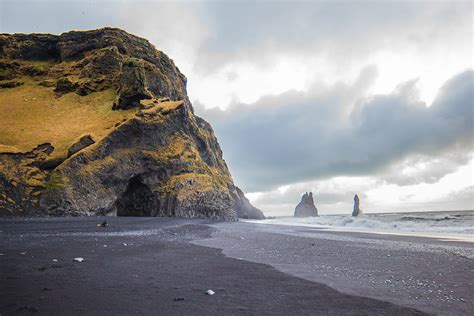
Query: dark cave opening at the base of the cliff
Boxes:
[{"xmin": 116, "ymin": 176, "xmax": 159, "ymax": 216}]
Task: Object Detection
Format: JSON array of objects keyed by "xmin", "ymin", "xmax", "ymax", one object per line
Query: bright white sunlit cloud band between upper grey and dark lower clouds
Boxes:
[{"xmin": 189, "ymin": 44, "xmax": 472, "ymax": 109}]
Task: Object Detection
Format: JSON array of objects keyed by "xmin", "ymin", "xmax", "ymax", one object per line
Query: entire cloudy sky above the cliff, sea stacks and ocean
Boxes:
[{"xmin": 0, "ymin": 0, "xmax": 474, "ymax": 215}]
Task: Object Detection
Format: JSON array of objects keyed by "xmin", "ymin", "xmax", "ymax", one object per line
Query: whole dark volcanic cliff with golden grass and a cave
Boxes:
[{"xmin": 0, "ymin": 28, "xmax": 263, "ymax": 219}]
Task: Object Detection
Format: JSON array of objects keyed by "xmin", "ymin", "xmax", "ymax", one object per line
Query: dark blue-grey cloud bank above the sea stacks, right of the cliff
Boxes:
[{"xmin": 197, "ymin": 70, "xmax": 474, "ymax": 191}]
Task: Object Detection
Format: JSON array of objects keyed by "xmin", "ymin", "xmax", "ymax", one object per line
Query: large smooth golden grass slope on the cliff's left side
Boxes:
[{"xmin": 0, "ymin": 77, "xmax": 135, "ymax": 157}]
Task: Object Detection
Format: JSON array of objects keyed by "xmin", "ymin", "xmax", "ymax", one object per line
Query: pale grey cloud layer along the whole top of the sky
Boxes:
[{"xmin": 0, "ymin": 0, "xmax": 472, "ymax": 74}]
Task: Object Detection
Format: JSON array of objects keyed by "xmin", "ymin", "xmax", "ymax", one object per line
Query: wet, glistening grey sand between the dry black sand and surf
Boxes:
[{"xmin": 193, "ymin": 222, "xmax": 474, "ymax": 315}]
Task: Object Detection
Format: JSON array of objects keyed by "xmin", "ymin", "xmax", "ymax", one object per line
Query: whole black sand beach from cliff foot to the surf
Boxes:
[{"xmin": 0, "ymin": 217, "xmax": 474, "ymax": 315}]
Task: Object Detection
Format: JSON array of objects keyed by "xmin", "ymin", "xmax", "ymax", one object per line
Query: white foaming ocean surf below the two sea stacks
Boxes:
[{"xmin": 246, "ymin": 210, "xmax": 474, "ymax": 242}]
